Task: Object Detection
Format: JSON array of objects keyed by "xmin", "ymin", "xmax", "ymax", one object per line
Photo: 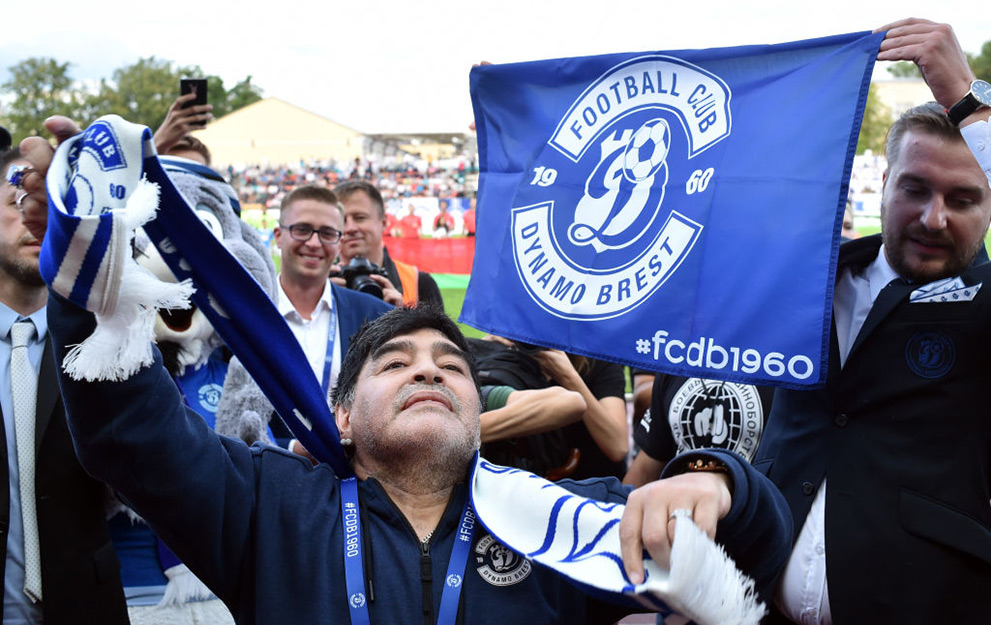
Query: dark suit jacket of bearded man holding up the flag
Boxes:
[{"xmin": 754, "ymin": 237, "xmax": 991, "ymax": 625}]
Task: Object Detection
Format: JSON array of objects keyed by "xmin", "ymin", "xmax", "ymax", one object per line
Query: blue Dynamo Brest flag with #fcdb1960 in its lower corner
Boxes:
[{"xmin": 460, "ymin": 33, "xmax": 884, "ymax": 387}]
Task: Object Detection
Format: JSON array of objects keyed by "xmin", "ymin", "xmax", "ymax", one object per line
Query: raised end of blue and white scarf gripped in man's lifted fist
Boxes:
[{"xmin": 41, "ymin": 115, "xmax": 351, "ymax": 476}]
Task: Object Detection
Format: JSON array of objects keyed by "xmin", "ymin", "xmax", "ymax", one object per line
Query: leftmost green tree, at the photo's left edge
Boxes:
[{"xmin": 3, "ymin": 57, "xmax": 82, "ymax": 145}]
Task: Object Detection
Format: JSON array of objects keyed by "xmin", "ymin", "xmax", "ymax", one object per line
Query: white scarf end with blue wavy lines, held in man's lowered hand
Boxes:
[{"xmin": 471, "ymin": 456, "xmax": 764, "ymax": 625}]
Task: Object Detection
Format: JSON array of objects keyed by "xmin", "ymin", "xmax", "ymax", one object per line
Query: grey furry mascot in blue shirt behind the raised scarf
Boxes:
[{"xmin": 110, "ymin": 156, "xmax": 276, "ymax": 625}]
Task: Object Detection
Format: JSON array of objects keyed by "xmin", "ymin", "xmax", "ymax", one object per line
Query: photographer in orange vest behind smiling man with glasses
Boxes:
[{"xmin": 334, "ymin": 180, "xmax": 444, "ymax": 306}]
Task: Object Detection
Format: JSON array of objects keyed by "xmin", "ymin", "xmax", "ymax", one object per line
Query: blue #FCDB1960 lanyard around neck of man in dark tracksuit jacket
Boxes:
[{"xmin": 341, "ymin": 477, "xmax": 475, "ymax": 625}]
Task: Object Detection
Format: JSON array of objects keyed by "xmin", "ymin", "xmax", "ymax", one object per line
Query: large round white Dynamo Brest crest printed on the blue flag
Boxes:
[{"xmin": 512, "ymin": 55, "xmax": 730, "ymax": 320}]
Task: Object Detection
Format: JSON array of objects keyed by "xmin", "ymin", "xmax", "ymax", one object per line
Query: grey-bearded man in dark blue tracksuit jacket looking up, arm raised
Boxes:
[{"xmin": 49, "ymin": 296, "xmax": 791, "ymax": 625}]
